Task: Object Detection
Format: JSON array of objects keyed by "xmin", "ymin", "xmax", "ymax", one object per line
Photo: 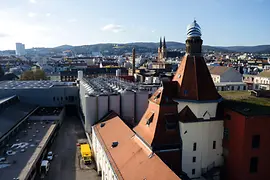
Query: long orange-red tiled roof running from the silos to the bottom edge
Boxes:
[{"xmin": 94, "ymin": 114, "xmax": 179, "ymax": 180}]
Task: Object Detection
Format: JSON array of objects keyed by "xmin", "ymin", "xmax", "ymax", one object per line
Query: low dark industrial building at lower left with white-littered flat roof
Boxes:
[{"xmin": 0, "ymin": 96, "xmax": 65, "ymax": 180}]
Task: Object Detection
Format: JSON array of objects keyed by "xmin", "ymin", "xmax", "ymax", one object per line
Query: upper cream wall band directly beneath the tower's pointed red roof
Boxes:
[{"xmin": 176, "ymin": 100, "xmax": 217, "ymax": 118}]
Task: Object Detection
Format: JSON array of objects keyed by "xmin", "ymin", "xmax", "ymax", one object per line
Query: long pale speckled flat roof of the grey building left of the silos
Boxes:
[{"xmin": 0, "ymin": 81, "xmax": 72, "ymax": 89}]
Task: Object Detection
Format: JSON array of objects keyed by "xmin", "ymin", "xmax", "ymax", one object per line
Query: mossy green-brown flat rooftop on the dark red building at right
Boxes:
[{"xmin": 219, "ymin": 91, "xmax": 270, "ymax": 116}]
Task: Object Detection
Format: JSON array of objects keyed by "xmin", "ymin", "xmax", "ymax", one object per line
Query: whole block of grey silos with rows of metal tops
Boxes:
[{"xmin": 78, "ymin": 71, "xmax": 149, "ymax": 132}]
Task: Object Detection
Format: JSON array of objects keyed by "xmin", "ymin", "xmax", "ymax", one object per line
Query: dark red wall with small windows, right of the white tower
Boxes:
[{"xmin": 223, "ymin": 109, "xmax": 270, "ymax": 180}]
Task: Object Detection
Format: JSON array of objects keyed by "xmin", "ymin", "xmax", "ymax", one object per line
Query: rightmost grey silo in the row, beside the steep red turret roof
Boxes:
[{"xmin": 135, "ymin": 91, "xmax": 148, "ymax": 123}]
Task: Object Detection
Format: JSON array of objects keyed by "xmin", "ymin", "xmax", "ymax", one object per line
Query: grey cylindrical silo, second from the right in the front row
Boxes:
[{"xmin": 121, "ymin": 90, "xmax": 135, "ymax": 124}]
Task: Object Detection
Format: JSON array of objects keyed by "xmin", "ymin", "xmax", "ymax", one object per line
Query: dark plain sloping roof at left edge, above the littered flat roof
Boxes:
[{"xmin": 0, "ymin": 102, "xmax": 37, "ymax": 138}]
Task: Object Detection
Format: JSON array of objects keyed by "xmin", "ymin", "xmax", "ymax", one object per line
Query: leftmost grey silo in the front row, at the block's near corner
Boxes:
[{"xmin": 85, "ymin": 95, "xmax": 98, "ymax": 133}]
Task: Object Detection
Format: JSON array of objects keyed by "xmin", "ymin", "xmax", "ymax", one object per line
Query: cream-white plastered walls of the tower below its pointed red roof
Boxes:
[{"xmin": 175, "ymin": 100, "xmax": 224, "ymax": 178}]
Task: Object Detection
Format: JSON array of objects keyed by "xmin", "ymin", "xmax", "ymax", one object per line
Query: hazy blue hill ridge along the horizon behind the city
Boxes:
[{"xmin": 0, "ymin": 41, "xmax": 270, "ymax": 55}]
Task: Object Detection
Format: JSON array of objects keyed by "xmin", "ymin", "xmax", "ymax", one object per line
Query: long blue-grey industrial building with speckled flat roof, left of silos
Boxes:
[{"xmin": 0, "ymin": 81, "xmax": 79, "ymax": 107}]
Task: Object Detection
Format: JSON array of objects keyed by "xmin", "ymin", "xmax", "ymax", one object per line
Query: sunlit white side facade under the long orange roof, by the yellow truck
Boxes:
[{"xmin": 92, "ymin": 130, "xmax": 118, "ymax": 180}]
